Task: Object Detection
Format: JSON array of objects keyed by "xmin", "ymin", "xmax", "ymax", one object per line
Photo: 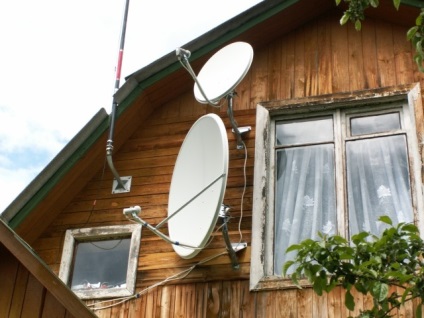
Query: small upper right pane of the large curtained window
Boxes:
[{"xmin": 350, "ymin": 113, "xmax": 401, "ymax": 136}]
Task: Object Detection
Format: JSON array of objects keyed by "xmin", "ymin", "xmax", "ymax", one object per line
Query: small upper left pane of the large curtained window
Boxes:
[{"xmin": 276, "ymin": 118, "xmax": 333, "ymax": 146}]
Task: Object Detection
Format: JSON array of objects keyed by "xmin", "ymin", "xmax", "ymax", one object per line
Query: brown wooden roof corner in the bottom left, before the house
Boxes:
[{"xmin": 0, "ymin": 220, "xmax": 94, "ymax": 318}]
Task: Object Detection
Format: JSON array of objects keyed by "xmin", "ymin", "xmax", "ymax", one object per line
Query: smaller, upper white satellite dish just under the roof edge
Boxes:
[{"xmin": 194, "ymin": 42, "xmax": 253, "ymax": 104}]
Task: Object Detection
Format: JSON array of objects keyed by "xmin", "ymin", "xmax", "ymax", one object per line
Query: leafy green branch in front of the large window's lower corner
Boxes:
[{"xmin": 283, "ymin": 216, "xmax": 424, "ymax": 318}]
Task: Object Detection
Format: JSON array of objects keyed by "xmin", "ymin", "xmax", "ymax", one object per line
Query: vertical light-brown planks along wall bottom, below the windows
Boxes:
[{"xmin": 88, "ymin": 281, "xmax": 420, "ymax": 318}]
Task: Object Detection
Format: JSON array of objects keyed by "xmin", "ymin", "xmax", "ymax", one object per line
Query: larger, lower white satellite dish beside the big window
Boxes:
[{"xmin": 167, "ymin": 114, "xmax": 228, "ymax": 259}]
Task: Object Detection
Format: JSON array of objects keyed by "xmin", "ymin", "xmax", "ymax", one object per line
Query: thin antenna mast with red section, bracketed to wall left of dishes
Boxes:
[{"xmin": 106, "ymin": 0, "xmax": 131, "ymax": 193}]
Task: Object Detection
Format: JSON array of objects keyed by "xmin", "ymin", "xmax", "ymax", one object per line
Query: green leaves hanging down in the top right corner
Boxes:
[{"xmin": 335, "ymin": 0, "xmax": 424, "ymax": 72}]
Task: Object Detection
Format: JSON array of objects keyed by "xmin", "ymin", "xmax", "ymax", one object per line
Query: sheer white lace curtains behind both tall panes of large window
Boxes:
[{"xmin": 274, "ymin": 135, "xmax": 413, "ymax": 275}]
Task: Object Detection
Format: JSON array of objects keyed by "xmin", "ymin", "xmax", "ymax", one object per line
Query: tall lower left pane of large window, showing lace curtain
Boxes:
[{"xmin": 274, "ymin": 144, "xmax": 337, "ymax": 275}]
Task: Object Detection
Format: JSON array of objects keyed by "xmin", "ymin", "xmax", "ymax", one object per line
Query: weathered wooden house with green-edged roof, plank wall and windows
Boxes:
[{"xmin": 2, "ymin": 0, "xmax": 424, "ymax": 318}]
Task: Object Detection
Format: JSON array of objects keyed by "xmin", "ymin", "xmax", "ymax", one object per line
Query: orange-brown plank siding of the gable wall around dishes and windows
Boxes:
[{"xmin": 31, "ymin": 12, "xmax": 423, "ymax": 318}]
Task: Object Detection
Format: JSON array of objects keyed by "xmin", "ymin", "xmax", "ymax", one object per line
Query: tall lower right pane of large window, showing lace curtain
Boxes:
[{"xmin": 346, "ymin": 136, "xmax": 413, "ymax": 235}]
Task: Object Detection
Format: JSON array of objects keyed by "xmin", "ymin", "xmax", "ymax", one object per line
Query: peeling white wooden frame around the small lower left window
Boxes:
[{"xmin": 59, "ymin": 224, "xmax": 142, "ymax": 299}]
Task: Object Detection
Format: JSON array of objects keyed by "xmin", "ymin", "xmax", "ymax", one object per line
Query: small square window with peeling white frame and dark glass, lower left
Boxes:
[{"xmin": 59, "ymin": 224, "xmax": 141, "ymax": 299}]
